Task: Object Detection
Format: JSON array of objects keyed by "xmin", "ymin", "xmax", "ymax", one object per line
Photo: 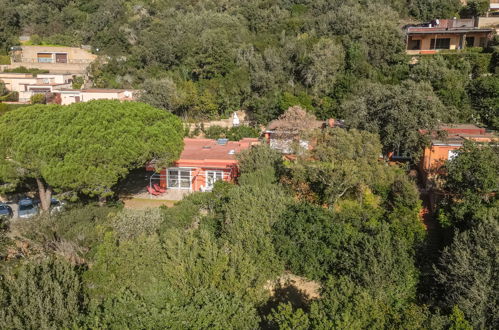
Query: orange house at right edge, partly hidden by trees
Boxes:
[{"xmin": 420, "ymin": 124, "xmax": 498, "ymax": 180}]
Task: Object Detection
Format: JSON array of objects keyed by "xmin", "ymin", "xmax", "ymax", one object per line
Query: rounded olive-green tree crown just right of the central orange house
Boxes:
[{"xmin": 290, "ymin": 128, "xmax": 383, "ymax": 206}]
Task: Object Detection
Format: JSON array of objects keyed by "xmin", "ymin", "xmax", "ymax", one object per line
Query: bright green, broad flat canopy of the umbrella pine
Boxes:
[{"xmin": 0, "ymin": 101, "xmax": 182, "ymax": 200}]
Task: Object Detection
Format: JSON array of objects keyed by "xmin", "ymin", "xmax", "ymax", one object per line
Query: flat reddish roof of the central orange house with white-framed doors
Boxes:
[{"xmin": 178, "ymin": 138, "xmax": 258, "ymax": 163}]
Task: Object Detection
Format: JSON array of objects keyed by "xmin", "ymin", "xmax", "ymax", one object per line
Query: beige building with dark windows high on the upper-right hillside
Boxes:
[{"xmin": 406, "ymin": 19, "xmax": 494, "ymax": 54}]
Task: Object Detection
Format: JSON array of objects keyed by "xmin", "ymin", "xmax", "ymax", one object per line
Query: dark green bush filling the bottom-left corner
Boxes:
[{"xmin": 0, "ymin": 259, "xmax": 86, "ymax": 329}]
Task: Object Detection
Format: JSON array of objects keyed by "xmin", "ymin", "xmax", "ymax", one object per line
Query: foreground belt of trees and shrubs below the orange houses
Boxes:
[{"xmin": 0, "ymin": 130, "xmax": 499, "ymax": 329}]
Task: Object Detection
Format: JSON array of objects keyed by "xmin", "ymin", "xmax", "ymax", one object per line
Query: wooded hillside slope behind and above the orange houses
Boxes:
[{"xmin": 0, "ymin": 0, "xmax": 499, "ymax": 133}]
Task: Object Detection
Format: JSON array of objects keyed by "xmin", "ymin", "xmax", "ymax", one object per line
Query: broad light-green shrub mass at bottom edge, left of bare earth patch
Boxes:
[{"xmin": 85, "ymin": 231, "xmax": 258, "ymax": 329}]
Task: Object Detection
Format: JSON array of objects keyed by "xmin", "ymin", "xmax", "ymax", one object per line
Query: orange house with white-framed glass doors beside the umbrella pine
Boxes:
[{"xmin": 147, "ymin": 138, "xmax": 259, "ymax": 191}]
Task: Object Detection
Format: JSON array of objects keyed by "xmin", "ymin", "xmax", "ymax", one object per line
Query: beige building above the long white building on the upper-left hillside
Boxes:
[{"xmin": 9, "ymin": 46, "xmax": 97, "ymax": 74}]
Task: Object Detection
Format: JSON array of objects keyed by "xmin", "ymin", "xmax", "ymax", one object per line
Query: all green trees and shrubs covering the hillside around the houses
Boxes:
[{"xmin": 0, "ymin": 0, "xmax": 499, "ymax": 330}]
